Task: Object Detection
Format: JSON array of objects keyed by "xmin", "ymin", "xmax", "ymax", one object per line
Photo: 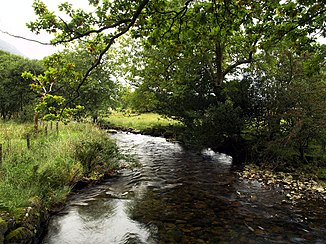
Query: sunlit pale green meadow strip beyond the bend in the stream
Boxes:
[{"xmin": 104, "ymin": 111, "xmax": 180, "ymax": 131}]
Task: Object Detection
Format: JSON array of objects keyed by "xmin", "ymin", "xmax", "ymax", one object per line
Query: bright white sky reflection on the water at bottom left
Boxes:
[{"xmin": 44, "ymin": 196, "xmax": 150, "ymax": 243}]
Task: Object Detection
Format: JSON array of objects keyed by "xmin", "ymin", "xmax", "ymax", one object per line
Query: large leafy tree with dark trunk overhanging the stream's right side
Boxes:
[{"xmin": 123, "ymin": 1, "xmax": 325, "ymax": 147}]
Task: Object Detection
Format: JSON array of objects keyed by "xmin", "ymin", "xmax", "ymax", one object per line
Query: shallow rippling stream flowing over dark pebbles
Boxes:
[{"xmin": 42, "ymin": 133, "xmax": 326, "ymax": 244}]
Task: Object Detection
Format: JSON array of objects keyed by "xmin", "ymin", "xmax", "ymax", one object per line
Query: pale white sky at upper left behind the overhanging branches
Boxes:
[{"xmin": 0, "ymin": 0, "xmax": 88, "ymax": 59}]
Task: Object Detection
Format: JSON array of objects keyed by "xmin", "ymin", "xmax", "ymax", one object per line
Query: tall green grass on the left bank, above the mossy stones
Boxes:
[{"xmin": 0, "ymin": 122, "xmax": 118, "ymax": 212}]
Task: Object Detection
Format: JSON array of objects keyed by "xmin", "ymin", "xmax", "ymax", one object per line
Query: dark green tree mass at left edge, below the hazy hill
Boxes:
[{"xmin": 0, "ymin": 51, "xmax": 44, "ymax": 119}]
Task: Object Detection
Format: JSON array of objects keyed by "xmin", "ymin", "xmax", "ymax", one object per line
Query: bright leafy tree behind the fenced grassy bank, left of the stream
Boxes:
[{"xmin": 23, "ymin": 42, "xmax": 117, "ymax": 128}]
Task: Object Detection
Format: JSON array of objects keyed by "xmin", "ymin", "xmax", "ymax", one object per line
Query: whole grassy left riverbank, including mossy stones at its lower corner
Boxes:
[{"xmin": 0, "ymin": 122, "xmax": 120, "ymax": 243}]
